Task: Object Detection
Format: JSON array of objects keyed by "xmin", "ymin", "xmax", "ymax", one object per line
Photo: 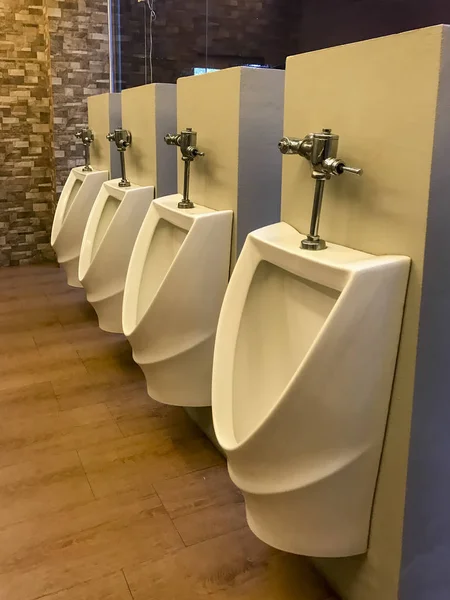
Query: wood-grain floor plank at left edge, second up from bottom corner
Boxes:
[{"xmin": 0, "ymin": 452, "xmax": 93, "ymax": 528}]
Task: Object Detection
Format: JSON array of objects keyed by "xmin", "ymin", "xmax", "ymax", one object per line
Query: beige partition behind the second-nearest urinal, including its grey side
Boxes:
[{"xmin": 177, "ymin": 67, "xmax": 284, "ymax": 257}]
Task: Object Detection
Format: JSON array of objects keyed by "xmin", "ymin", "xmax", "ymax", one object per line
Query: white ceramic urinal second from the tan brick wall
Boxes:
[{"xmin": 78, "ymin": 179, "xmax": 155, "ymax": 333}]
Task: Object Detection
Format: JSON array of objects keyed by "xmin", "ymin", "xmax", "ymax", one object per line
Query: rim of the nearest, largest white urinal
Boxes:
[{"xmin": 212, "ymin": 222, "xmax": 410, "ymax": 454}]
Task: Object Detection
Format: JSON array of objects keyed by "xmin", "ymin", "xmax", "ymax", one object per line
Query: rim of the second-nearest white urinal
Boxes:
[{"xmin": 122, "ymin": 194, "xmax": 233, "ymax": 343}]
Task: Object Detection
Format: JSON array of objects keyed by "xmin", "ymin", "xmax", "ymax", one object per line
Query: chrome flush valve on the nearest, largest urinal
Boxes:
[{"xmin": 278, "ymin": 129, "xmax": 363, "ymax": 250}]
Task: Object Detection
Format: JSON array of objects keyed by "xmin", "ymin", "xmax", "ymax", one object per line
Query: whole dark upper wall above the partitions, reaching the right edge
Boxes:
[{"xmin": 112, "ymin": 0, "xmax": 450, "ymax": 90}]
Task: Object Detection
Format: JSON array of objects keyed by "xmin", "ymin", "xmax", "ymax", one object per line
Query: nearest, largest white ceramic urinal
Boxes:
[{"xmin": 212, "ymin": 223, "xmax": 410, "ymax": 557}]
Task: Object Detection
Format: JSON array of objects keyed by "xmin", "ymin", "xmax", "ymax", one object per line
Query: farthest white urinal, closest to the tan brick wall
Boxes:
[{"xmin": 51, "ymin": 167, "xmax": 108, "ymax": 287}]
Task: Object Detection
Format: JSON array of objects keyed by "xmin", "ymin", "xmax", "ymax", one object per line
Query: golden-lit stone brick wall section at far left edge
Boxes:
[{"xmin": 0, "ymin": 0, "xmax": 54, "ymax": 266}]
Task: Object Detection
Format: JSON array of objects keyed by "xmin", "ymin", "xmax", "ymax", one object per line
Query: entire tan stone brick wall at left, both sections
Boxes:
[{"xmin": 0, "ymin": 0, "xmax": 109, "ymax": 266}]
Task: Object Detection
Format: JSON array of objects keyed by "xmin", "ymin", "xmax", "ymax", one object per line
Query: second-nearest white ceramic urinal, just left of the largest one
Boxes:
[{"xmin": 123, "ymin": 194, "xmax": 233, "ymax": 406}]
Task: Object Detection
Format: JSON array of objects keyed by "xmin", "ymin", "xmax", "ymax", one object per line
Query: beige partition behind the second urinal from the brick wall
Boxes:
[{"xmin": 122, "ymin": 83, "xmax": 177, "ymax": 196}]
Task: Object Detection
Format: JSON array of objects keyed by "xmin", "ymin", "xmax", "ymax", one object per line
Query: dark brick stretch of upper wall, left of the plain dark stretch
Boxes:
[{"xmin": 112, "ymin": 0, "xmax": 300, "ymax": 90}]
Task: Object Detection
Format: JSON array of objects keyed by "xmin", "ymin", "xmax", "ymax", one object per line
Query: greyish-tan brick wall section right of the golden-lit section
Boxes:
[{"xmin": 46, "ymin": 0, "xmax": 109, "ymax": 194}]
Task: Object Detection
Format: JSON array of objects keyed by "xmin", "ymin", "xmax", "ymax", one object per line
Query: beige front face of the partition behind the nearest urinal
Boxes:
[{"xmin": 281, "ymin": 26, "xmax": 450, "ymax": 600}]
